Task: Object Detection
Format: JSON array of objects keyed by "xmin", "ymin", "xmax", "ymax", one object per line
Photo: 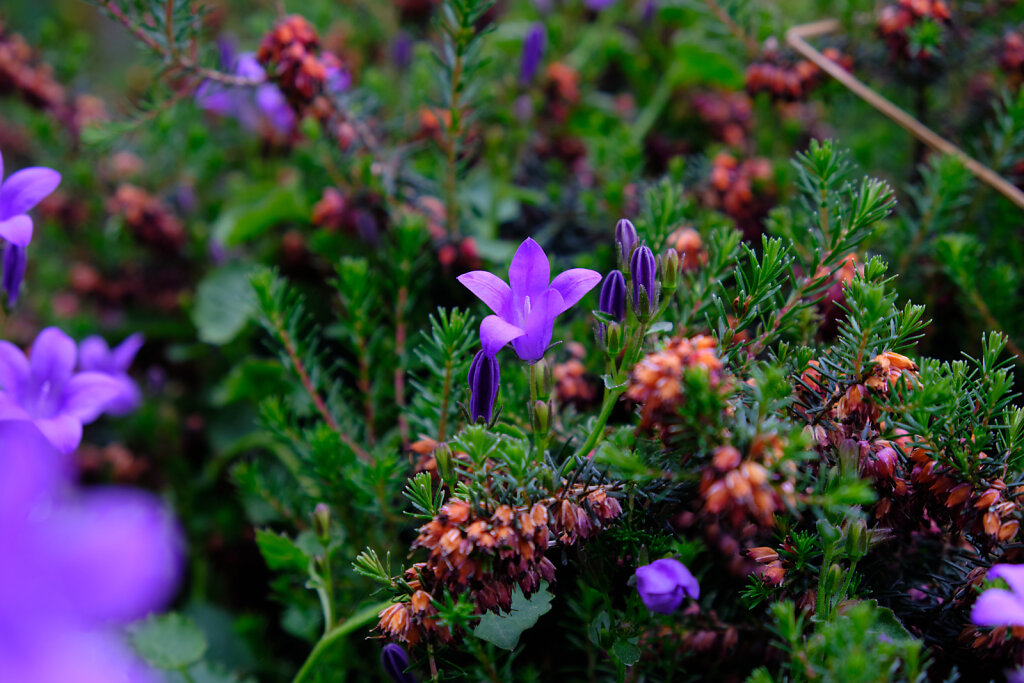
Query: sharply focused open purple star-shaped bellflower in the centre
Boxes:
[{"xmin": 459, "ymin": 238, "xmax": 601, "ymax": 362}]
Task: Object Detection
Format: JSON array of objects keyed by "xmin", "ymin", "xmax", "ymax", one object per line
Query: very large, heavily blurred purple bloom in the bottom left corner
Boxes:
[{"xmin": 0, "ymin": 422, "xmax": 182, "ymax": 683}]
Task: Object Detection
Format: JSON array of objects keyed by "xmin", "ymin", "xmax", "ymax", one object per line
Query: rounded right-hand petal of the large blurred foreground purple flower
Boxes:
[{"xmin": 46, "ymin": 488, "xmax": 182, "ymax": 624}]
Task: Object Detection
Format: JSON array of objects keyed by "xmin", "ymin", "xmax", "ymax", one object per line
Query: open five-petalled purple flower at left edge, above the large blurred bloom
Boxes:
[{"xmin": 0, "ymin": 328, "xmax": 122, "ymax": 453}]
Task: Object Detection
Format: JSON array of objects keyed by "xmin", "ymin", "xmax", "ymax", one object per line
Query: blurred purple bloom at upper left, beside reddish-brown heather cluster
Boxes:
[{"xmin": 196, "ymin": 44, "xmax": 299, "ymax": 135}]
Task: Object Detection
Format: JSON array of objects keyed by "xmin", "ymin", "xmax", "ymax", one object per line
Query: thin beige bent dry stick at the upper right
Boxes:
[{"xmin": 785, "ymin": 19, "xmax": 1024, "ymax": 209}]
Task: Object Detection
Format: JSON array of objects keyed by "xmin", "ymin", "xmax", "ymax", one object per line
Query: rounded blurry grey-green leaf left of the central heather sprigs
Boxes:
[{"xmin": 193, "ymin": 263, "xmax": 256, "ymax": 346}]
